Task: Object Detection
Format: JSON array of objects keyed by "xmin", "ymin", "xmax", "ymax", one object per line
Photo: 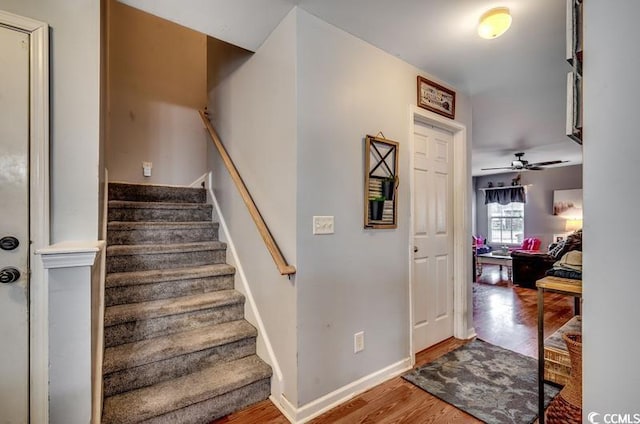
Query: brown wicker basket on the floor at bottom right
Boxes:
[{"xmin": 545, "ymin": 333, "xmax": 582, "ymax": 424}]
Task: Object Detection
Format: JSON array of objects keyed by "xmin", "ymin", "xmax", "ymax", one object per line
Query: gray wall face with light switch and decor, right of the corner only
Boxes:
[{"xmin": 296, "ymin": 9, "xmax": 471, "ymax": 405}]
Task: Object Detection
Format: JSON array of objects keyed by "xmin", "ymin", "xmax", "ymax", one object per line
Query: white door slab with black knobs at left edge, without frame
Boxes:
[{"xmin": 0, "ymin": 26, "xmax": 29, "ymax": 424}]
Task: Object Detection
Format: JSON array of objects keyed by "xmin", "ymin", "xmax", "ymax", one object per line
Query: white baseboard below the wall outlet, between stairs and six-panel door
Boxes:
[{"xmin": 282, "ymin": 357, "xmax": 411, "ymax": 424}]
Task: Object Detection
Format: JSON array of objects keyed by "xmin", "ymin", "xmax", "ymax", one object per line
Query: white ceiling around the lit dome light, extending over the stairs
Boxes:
[{"xmin": 120, "ymin": 0, "xmax": 582, "ymax": 175}]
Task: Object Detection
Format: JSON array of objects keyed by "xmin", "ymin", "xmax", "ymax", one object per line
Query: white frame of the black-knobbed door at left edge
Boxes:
[{"xmin": 0, "ymin": 10, "xmax": 49, "ymax": 423}]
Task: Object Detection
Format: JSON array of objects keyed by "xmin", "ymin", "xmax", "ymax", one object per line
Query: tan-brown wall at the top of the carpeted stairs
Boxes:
[{"xmin": 106, "ymin": 0, "xmax": 208, "ymax": 185}]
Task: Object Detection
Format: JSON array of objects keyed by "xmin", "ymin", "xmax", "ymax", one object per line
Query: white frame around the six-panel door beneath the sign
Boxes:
[{"xmin": 408, "ymin": 105, "xmax": 476, "ymax": 365}]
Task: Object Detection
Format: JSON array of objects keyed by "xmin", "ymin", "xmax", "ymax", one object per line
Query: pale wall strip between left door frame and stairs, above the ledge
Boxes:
[{"xmin": 0, "ymin": 0, "xmax": 100, "ymax": 243}]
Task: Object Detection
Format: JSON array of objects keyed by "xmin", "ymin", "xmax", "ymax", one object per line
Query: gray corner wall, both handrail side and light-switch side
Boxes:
[{"xmin": 209, "ymin": 8, "xmax": 471, "ymax": 407}]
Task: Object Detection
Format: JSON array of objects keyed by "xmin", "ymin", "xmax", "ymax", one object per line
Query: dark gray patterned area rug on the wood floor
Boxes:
[{"xmin": 402, "ymin": 339, "xmax": 559, "ymax": 424}]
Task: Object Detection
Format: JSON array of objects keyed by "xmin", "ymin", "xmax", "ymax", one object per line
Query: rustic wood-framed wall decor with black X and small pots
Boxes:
[{"xmin": 364, "ymin": 133, "xmax": 399, "ymax": 228}]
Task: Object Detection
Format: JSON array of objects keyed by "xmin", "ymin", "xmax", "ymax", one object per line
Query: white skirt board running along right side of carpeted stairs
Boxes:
[{"xmin": 190, "ymin": 172, "xmax": 294, "ymax": 422}]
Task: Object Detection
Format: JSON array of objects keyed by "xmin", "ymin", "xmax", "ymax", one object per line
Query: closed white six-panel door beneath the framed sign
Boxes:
[{"xmin": 411, "ymin": 122, "xmax": 453, "ymax": 353}]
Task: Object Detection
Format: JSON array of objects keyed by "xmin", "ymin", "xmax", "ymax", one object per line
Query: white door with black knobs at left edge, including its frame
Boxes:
[{"xmin": 0, "ymin": 10, "xmax": 49, "ymax": 424}]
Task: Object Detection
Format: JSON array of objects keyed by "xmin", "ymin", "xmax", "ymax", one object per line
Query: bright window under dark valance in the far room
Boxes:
[{"xmin": 487, "ymin": 203, "xmax": 524, "ymax": 244}]
